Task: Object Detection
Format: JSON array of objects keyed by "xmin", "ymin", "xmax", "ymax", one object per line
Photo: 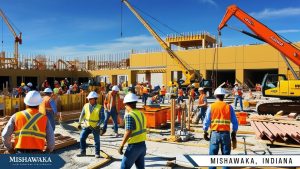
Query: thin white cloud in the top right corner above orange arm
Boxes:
[{"xmin": 250, "ymin": 8, "xmax": 300, "ymax": 19}]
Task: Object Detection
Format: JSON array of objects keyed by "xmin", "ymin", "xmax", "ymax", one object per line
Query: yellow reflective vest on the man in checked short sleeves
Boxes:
[{"xmin": 127, "ymin": 110, "xmax": 147, "ymax": 144}]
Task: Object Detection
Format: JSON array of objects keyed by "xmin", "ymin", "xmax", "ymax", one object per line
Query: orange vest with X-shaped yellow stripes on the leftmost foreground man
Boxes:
[{"xmin": 14, "ymin": 109, "xmax": 47, "ymax": 150}]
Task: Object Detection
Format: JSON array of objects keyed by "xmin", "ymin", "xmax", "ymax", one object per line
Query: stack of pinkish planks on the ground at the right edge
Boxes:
[{"xmin": 250, "ymin": 120, "xmax": 300, "ymax": 145}]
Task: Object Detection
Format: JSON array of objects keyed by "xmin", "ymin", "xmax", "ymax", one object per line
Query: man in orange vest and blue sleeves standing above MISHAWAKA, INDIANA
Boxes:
[{"xmin": 203, "ymin": 88, "xmax": 238, "ymax": 168}]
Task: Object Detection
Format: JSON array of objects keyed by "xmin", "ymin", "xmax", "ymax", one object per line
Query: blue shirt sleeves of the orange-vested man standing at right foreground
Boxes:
[{"xmin": 203, "ymin": 103, "xmax": 239, "ymax": 132}]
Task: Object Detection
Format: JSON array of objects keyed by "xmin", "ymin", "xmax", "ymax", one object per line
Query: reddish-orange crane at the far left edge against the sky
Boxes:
[{"xmin": 0, "ymin": 9, "xmax": 22, "ymax": 68}]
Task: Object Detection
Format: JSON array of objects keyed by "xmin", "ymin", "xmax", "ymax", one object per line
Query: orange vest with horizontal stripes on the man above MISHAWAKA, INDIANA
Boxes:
[{"xmin": 210, "ymin": 101, "xmax": 230, "ymax": 131}]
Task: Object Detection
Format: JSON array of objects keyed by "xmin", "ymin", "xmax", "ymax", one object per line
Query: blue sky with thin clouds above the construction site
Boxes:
[{"xmin": 0, "ymin": 0, "xmax": 300, "ymax": 57}]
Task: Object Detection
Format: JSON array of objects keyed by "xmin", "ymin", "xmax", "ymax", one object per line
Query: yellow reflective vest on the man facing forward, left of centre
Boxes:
[{"xmin": 84, "ymin": 103, "xmax": 101, "ymax": 127}]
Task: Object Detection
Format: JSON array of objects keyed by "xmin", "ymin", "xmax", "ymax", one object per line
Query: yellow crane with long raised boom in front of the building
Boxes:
[{"xmin": 121, "ymin": 0, "xmax": 205, "ymax": 90}]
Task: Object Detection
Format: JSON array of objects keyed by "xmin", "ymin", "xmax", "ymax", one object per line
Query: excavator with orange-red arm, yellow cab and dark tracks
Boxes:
[{"xmin": 218, "ymin": 5, "xmax": 300, "ymax": 114}]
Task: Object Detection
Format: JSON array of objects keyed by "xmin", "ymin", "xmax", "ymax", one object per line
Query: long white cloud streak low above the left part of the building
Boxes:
[{"xmin": 32, "ymin": 35, "xmax": 159, "ymax": 57}]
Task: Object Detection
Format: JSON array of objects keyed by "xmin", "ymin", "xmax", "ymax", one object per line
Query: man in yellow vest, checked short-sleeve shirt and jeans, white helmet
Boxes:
[{"xmin": 118, "ymin": 93, "xmax": 147, "ymax": 169}]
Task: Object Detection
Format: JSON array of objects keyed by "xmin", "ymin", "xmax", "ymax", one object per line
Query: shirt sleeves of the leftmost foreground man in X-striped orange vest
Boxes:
[{"xmin": 1, "ymin": 114, "xmax": 55, "ymax": 152}]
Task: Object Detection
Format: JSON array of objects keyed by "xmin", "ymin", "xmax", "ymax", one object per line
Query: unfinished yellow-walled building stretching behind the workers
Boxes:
[{"xmin": 0, "ymin": 32, "xmax": 299, "ymax": 91}]
